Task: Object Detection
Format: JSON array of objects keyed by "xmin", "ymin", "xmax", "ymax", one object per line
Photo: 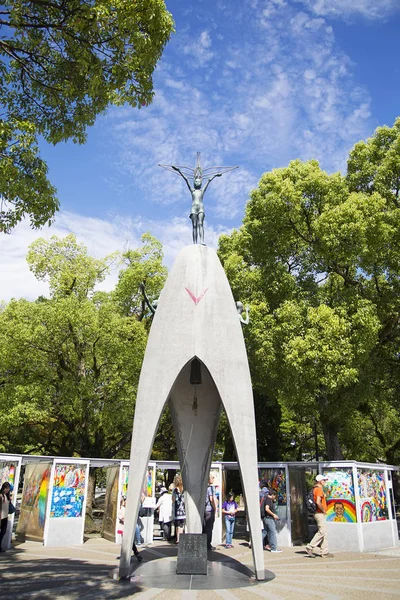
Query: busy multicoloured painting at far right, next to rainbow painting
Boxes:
[{"xmin": 357, "ymin": 469, "xmax": 389, "ymax": 523}]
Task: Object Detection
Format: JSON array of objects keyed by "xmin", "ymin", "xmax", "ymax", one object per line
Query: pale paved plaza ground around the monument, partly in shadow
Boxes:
[{"xmin": 0, "ymin": 538, "xmax": 400, "ymax": 600}]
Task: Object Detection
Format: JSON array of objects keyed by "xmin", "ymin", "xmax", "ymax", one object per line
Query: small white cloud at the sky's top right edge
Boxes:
[{"xmin": 300, "ymin": 0, "xmax": 400, "ymax": 21}]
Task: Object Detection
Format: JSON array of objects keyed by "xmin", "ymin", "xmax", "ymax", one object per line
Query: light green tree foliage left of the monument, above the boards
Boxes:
[{"xmin": 0, "ymin": 235, "xmax": 165, "ymax": 457}]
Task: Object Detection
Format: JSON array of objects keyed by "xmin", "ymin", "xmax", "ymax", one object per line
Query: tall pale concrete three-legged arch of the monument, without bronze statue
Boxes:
[{"xmin": 119, "ymin": 245, "xmax": 264, "ymax": 579}]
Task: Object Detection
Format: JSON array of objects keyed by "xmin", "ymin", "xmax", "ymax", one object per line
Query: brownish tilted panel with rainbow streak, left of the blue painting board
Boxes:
[{"xmin": 17, "ymin": 462, "xmax": 51, "ymax": 542}]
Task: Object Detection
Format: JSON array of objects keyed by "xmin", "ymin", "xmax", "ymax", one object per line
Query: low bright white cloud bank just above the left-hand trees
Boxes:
[{"xmin": 0, "ymin": 212, "xmax": 229, "ymax": 301}]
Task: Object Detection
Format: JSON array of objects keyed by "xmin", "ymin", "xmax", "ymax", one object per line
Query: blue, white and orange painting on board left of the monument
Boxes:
[{"xmin": 50, "ymin": 464, "xmax": 86, "ymax": 518}]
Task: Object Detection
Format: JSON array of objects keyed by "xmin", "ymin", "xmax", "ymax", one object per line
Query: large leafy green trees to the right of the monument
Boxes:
[{"xmin": 219, "ymin": 120, "xmax": 400, "ymax": 459}]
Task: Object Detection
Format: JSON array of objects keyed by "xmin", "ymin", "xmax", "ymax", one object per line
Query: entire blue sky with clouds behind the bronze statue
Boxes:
[{"xmin": 0, "ymin": 0, "xmax": 400, "ymax": 300}]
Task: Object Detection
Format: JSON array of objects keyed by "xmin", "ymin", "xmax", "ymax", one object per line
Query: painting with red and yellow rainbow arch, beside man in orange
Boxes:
[{"xmin": 323, "ymin": 468, "xmax": 357, "ymax": 523}]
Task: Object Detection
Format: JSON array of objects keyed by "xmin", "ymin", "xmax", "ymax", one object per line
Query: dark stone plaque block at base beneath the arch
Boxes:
[{"xmin": 176, "ymin": 533, "xmax": 207, "ymax": 575}]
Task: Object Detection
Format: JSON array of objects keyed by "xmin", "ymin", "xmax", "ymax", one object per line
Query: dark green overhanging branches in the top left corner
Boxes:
[{"xmin": 0, "ymin": 0, "xmax": 173, "ymax": 232}]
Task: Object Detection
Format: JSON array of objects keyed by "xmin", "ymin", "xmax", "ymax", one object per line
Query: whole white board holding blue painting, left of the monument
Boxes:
[{"xmin": 44, "ymin": 458, "xmax": 90, "ymax": 546}]
